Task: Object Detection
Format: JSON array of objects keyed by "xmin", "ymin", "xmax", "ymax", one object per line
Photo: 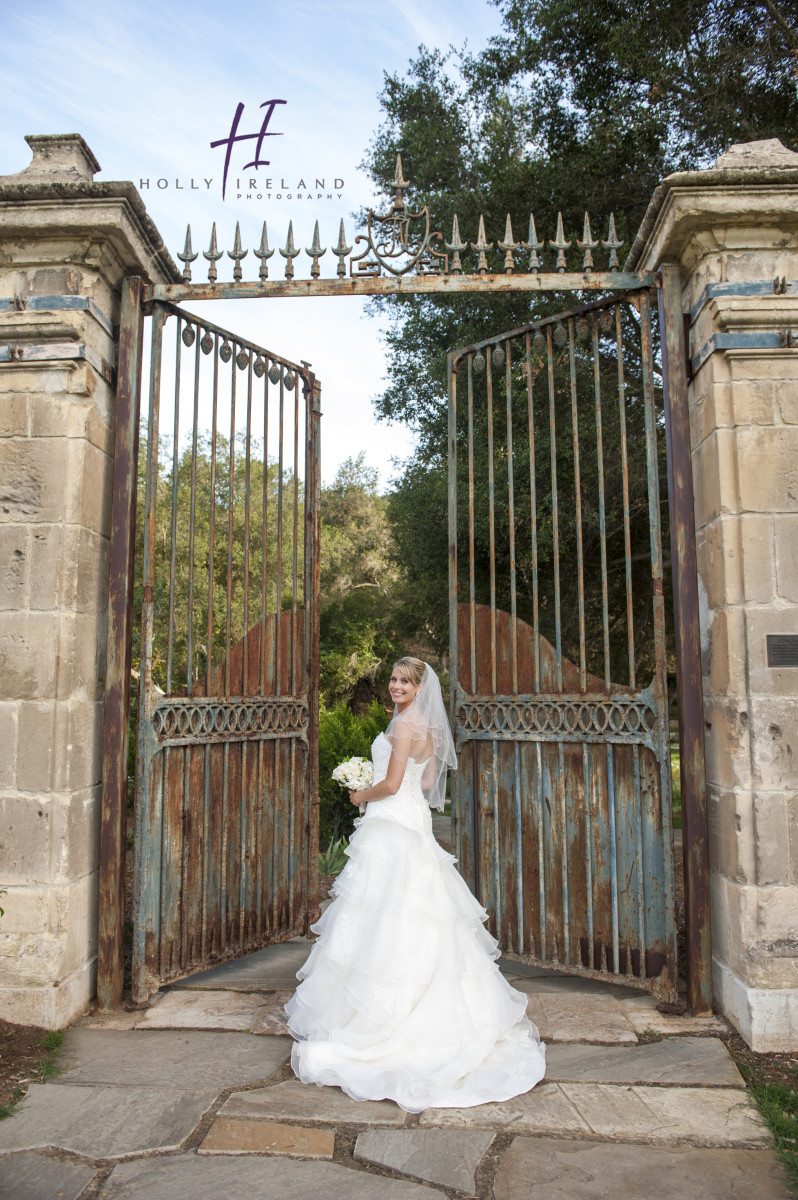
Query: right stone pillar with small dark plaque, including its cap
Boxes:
[{"xmin": 626, "ymin": 140, "xmax": 798, "ymax": 1051}]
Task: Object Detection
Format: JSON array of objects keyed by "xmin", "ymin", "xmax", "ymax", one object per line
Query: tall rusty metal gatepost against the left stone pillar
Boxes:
[{"xmin": 97, "ymin": 278, "xmax": 143, "ymax": 1008}]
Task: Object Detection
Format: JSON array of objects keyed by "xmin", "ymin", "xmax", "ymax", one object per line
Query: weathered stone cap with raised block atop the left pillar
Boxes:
[{"xmin": 0, "ymin": 133, "xmax": 181, "ymax": 287}]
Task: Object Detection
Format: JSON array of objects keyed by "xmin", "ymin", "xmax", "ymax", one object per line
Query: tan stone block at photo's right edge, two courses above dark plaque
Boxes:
[{"xmin": 732, "ymin": 426, "xmax": 798, "ymax": 512}]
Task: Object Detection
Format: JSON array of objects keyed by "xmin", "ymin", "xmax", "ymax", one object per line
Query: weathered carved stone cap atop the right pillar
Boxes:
[{"xmin": 624, "ymin": 138, "xmax": 798, "ymax": 271}]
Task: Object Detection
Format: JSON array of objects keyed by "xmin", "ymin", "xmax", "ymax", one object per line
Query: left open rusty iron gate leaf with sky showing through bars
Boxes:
[{"xmin": 133, "ymin": 302, "xmax": 319, "ymax": 1001}]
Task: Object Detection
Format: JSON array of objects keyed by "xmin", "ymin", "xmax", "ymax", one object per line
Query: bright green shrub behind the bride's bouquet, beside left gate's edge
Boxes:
[{"xmin": 319, "ymin": 701, "xmax": 390, "ymax": 847}]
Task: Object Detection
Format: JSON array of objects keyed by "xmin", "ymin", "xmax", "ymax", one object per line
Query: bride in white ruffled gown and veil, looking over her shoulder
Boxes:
[{"xmin": 286, "ymin": 658, "xmax": 545, "ymax": 1112}]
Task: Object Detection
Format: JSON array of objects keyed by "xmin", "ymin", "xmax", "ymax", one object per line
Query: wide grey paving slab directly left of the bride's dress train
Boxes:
[{"xmin": 53, "ymin": 1028, "xmax": 292, "ymax": 1092}]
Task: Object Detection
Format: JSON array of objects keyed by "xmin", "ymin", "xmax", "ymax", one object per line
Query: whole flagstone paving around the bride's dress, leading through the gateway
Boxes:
[{"xmin": 0, "ymin": 938, "xmax": 787, "ymax": 1200}]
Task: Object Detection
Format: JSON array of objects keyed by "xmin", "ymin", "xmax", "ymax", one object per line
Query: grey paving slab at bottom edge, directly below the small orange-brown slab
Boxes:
[{"xmin": 101, "ymin": 1154, "xmax": 444, "ymax": 1200}]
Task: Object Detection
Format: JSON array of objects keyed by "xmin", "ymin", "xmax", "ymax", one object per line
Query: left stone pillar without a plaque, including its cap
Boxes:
[{"xmin": 0, "ymin": 134, "xmax": 178, "ymax": 1028}]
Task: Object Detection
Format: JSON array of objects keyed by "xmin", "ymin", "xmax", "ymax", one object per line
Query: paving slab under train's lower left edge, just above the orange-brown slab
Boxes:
[{"xmin": 220, "ymin": 1079, "xmax": 407, "ymax": 1126}]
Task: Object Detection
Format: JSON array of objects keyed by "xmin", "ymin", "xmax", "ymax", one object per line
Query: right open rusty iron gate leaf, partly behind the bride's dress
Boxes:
[{"xmin": 449, "ymin": 288, "xmax": 677, "ymax": 1001}]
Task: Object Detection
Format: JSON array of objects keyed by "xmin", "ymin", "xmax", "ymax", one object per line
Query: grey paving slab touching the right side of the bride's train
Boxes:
[{"xmin": 546, "ymin": 1037, "xmax": 743, "ymax": 1087}]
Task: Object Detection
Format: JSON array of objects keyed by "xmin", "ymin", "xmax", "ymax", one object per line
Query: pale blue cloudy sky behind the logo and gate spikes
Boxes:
[{"xmin": 0, "ymin": 0, "xmax": 500, "ymax": 485}]
